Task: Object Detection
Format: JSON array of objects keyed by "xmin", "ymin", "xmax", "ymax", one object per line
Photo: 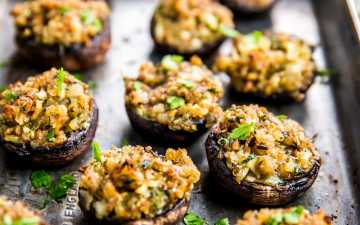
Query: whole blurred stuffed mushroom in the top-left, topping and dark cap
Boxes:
[{"xmin": 11, "ymin": 0, "xmax": 111, "ymax": 71}]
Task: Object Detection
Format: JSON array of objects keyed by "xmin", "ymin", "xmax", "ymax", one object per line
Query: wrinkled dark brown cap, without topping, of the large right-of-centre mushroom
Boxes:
[{"xmin": 205, "ymin": 125, "xmax": 320, "ymax": 206}]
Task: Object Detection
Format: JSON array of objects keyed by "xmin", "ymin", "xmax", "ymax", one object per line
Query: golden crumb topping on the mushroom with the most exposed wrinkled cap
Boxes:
[{"xmin": 215, "ymin": 105, "xmax": 320, "ymax": 186}]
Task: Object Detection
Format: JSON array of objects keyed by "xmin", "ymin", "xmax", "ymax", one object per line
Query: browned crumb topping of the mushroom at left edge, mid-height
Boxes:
[{"xmin": 0, "ymin": 69, "xmax": 94, "ymax": 147}]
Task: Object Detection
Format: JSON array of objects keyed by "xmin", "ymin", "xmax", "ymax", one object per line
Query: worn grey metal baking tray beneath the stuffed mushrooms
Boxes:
[{"xmin": 0, "ymin": 0, "xmax": 360, "ymax": 225}]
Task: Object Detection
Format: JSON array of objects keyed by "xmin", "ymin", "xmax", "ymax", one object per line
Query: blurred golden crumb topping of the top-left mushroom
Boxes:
[{"xmin": 11, "ymin": 0, "xmax": 110, "ymax": 46}]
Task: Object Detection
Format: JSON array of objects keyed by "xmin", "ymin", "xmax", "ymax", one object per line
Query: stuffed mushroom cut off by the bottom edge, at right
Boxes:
[{"xmin": 236, "ymin": 206, "xmax": 331, "ymax": 225}]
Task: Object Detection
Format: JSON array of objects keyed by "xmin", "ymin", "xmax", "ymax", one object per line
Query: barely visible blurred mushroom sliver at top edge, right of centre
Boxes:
[{"xmin": 221, "ymin": 0, "xmax": 276, "ymax": 14}]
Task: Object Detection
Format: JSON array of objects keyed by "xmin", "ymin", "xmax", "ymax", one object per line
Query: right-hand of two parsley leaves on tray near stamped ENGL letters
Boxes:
[{"xmin": 49, "ymin": 174, "xmax": 75, "ymax": 201}]
